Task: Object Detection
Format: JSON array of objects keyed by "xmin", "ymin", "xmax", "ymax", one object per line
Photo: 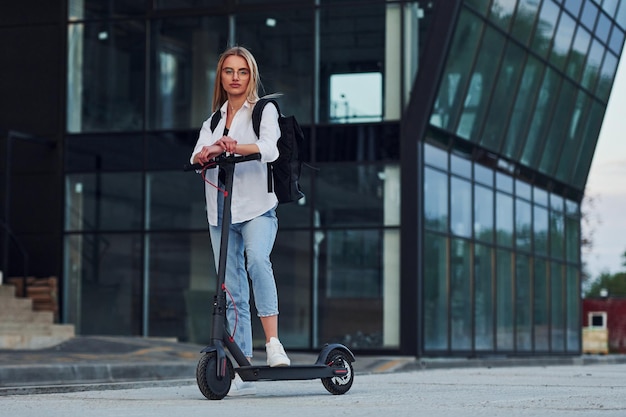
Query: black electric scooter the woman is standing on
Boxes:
[{"xmin": 185, "ymin": 153, "xmax": 356, "ymax": 400}]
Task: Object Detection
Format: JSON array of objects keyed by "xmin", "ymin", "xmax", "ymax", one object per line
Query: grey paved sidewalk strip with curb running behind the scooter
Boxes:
[{"xmin": 0, "ymin": 336, "xmax": 626, "ymax": 396}]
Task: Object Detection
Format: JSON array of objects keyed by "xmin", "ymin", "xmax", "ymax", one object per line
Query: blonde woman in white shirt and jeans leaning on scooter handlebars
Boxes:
[{"xmin": 191, "ymin": 47, "xmax": 291, "ymax": 395}]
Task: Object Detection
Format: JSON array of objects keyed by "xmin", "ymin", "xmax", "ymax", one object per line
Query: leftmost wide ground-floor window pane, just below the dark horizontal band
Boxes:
[{"xmin": 65, "ymin": 172, "xmax": 143, "ymax": 231}]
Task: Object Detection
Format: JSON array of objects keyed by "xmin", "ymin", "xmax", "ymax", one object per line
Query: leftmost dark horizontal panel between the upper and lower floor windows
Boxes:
[{"xmin": 64, "ymin": 135, "xmax": 144, "ymax": 172}]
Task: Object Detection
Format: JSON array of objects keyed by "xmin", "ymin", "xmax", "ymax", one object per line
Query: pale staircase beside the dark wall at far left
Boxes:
[{"xmin": 0, "ymin": 285, "xmax": 74, "ymax": 349}]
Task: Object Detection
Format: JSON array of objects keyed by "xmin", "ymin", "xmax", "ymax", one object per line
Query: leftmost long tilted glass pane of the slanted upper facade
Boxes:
[{"xmin": 430, "ymin": 9, "xmax": 483, "ymax": 130}]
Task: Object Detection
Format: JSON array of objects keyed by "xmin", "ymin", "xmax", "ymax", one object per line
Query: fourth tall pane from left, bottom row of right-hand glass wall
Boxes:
[{"xmin": 496, "ymin": 250, "xmax": 515, "ymax": 351}]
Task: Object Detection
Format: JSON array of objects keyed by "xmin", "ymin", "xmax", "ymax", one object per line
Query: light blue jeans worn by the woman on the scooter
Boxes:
[{"xmin": 209, "ymin": 193, "xmax": 278, "ymax": 358}]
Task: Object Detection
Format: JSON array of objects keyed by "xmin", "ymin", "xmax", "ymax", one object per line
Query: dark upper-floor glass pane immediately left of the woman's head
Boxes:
[{"xmin": 148, "ymin": 16, "xmax": 227, "ymax": 129}]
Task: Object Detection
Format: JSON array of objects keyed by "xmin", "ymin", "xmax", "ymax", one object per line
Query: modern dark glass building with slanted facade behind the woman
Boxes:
[{"xmin": 0, "ymin": 0, "xmax": 626, "ymax": 356}]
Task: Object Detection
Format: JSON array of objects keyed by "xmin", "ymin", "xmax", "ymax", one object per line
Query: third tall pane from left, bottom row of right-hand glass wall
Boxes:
[{"xmin": 474, "ymin": 244, "xmax": 495, "ymax": 350}]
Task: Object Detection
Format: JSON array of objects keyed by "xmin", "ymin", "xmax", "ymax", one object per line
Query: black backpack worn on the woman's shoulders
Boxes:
[{"xmin": 211, "ymin": 98, "xmax": 304, "ymax": 204}]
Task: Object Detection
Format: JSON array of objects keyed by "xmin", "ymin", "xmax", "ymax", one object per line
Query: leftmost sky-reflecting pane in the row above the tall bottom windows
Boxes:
[{"xmin": 424, "ymin": 168, "xmax": 448, "ymax": 232}]
